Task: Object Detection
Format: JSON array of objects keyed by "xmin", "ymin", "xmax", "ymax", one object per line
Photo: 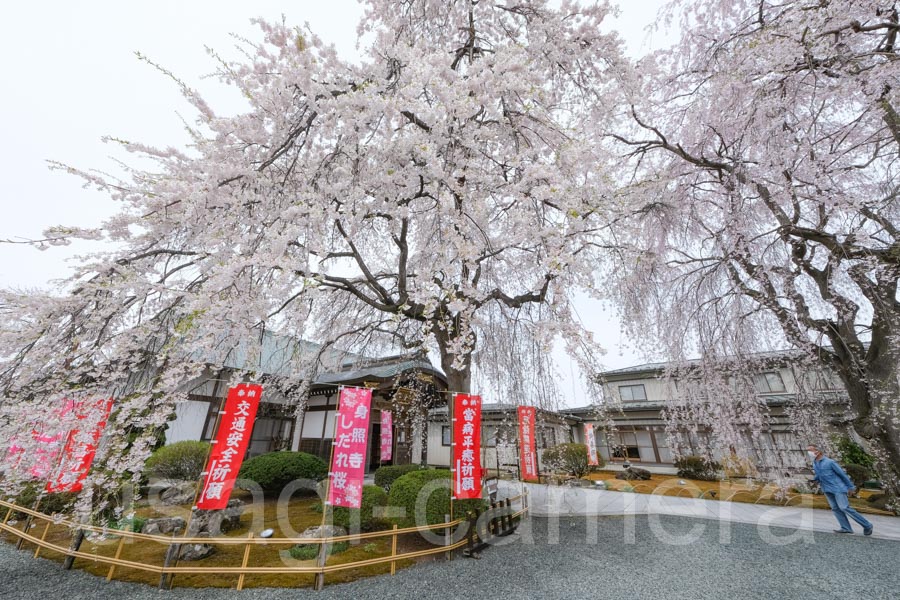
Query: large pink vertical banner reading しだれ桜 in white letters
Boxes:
[{"xmin": 326, "ymin": 388, "xmax": 372, "ymax": 508}]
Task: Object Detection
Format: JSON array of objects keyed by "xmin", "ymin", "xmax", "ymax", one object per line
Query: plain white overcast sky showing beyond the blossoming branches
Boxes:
[{"xmin": 0, "ymin": 0, "xmax": 676, "ymax": 406}]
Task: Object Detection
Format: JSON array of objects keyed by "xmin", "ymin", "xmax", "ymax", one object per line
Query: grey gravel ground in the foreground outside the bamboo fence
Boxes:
[{"xmin": 0, "ymin": 516, "xmax": 900, "ymax": 600}]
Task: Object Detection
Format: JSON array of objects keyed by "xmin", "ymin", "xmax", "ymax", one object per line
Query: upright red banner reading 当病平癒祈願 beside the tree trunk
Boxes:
[{"xmin": 452, "ymin": 394, "xmax": 481, "ymax": 500}]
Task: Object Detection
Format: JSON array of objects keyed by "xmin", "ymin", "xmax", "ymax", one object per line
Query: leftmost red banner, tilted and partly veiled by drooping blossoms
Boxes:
[{"xmin": 47, "ymin": 398, "xmax": 113, "ymax": 494}]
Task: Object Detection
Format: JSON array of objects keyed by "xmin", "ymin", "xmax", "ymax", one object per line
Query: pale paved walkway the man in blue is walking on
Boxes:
[{"xmin": 524, "ymin": 484, "xmax": 900, "ymax": 540}]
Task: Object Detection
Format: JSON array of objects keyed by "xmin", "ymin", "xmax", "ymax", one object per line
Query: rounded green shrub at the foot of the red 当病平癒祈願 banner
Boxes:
[{"xmin": 388, "ymin": 469, "xmax": 487, "ymax": 526}]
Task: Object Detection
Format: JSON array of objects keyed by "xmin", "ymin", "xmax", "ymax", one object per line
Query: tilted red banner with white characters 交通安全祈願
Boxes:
[{"xmin": 197, "ymin": 383, "xmax": 262, "ymax": 510}]
